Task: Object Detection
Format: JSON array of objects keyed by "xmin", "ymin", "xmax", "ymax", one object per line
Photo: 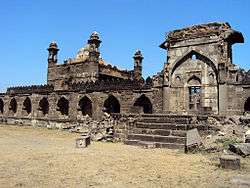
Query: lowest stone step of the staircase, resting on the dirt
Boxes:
[{"xmin": 124, "ymin": 140, "xmax": 185, "ymax": 150}]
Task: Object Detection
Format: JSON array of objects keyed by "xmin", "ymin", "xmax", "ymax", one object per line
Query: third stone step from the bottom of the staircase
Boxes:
[{"xmin": 131, "ymin": 128, "xmax": 186, "ymax": 137}]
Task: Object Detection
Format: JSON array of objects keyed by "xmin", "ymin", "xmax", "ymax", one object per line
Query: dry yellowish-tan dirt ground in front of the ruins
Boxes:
[{"xmin": 0, "ymin": 125, "xmax": 250, "ymax": 188}]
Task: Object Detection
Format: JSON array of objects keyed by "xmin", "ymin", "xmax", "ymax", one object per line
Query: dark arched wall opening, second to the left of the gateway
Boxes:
[{"xmin": 103, "ymin": 95, "xmax": 120, "ymax": 114}]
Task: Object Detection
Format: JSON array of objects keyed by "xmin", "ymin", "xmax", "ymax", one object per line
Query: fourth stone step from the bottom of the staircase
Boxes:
[{"xmin": 135, "ymin": 122, "xmax": 188, "ymax": 130}]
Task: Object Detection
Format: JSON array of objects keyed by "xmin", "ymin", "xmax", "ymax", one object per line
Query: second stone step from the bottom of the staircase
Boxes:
[{"xmin": 127, "ymin": 134, "xmax": 186, "ymax": 144}]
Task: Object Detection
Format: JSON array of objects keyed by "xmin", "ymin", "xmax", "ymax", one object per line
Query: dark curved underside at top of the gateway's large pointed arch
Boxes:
[{"xmin": 171, "ymin": 50, "xmax": 218, "ymax": 79}]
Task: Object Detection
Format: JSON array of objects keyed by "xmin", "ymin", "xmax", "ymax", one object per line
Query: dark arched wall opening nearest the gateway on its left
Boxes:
[{"xmin": 133, "ymin": 94, "xmax": 153, "ymax": 114}]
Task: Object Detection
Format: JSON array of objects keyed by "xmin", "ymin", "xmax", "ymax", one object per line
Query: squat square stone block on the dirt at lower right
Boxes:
[{"xmin": 220, "ymin": 154, "xmax": 240, "ymax": 170}]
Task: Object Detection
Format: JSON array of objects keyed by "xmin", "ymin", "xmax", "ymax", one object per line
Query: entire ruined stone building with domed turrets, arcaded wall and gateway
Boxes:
[{"xmin": 0, "ymin": 22, "xmax": 250, "ymax": 148}]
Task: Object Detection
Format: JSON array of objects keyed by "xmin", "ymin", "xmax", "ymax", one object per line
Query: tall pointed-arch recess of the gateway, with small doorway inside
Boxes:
[{"xmin": 168, "ymin": 49, "xmax": 219, "ymax": 114}]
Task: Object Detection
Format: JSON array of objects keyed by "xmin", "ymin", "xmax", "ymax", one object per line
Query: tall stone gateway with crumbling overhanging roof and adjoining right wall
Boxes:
[{"xmin": 160, "ymin": 23, "xmax": 250, "ymax": 115}]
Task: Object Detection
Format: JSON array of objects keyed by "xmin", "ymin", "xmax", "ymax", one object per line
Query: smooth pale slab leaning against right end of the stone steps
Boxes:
[{"xmin": 185, "ymin": 128, "xmax": 202, "ymax": 152}]
